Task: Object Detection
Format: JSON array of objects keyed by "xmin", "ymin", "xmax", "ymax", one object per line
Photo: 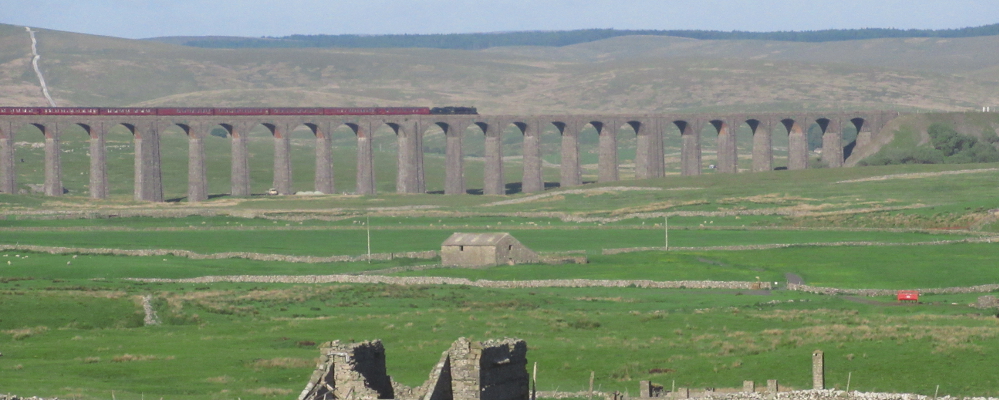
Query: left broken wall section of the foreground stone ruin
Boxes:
[{"xmin": 298, "ymin": 340, "xmax": 395, "ymax": 400}]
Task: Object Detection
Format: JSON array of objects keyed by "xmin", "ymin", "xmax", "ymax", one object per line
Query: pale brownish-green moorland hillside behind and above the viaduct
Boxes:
[{"xmin": 0, "ymin": 26, "xmax": 999, "ymax": 114}]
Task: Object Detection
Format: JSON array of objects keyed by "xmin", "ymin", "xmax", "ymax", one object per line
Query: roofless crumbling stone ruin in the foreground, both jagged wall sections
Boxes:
[{"xmin": 298, "ymin": 338, "xmax": 530, "ymax": 400}]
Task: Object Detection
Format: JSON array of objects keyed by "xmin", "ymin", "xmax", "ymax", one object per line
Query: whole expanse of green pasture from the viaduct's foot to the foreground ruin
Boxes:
[{"xmin": 0, "ymin": 161, "xmax": 999, "ymax": 400}]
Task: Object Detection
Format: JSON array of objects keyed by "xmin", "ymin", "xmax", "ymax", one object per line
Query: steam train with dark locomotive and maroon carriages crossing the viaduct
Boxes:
[{"xmin": 0, "ymin": 106, "xmax": 478, "ymax": 116}]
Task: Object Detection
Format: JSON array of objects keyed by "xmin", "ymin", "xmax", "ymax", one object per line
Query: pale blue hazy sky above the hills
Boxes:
[{"xmin": 0, "ymin": 0, "xmax": 999, "ymax": 38}]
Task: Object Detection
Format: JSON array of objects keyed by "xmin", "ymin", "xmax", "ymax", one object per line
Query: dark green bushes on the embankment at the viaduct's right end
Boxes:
[{"xmin": 859, "ymin": 122, "xmax": 999, "ymax": 165}]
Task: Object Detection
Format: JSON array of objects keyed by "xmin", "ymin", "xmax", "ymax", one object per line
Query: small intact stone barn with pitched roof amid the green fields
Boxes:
[{"xmin": 441, "ymin": 232, "xmax": 538, "ymax": 267}]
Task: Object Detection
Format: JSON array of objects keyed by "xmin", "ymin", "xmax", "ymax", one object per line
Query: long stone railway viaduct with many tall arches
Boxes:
[{"xmin": 0, "ymin": 111, "xmax": 899, "ymax": 201}]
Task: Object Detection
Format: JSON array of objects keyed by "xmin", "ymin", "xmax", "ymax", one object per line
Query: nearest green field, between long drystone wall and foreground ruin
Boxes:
[{"xmin": 0, "ymin": 280, "xmax": 999, "ymax": 399}]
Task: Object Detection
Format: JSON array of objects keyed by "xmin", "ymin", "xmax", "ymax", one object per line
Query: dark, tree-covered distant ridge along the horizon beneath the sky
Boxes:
[{"xmin": 147, "ymin": 24, "xmax": 999, "ymax": 50}]
